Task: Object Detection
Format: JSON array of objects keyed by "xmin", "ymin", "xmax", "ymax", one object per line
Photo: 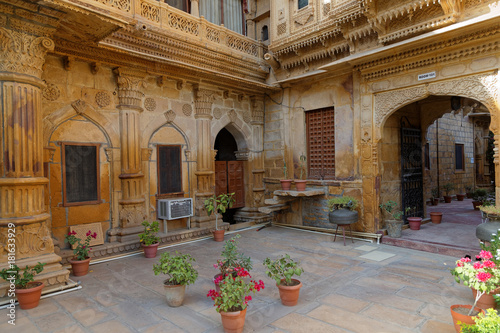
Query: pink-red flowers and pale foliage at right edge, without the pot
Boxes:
[{"xmin": 451, "ymin": 250, "xmax": 500, "ymax": 316}]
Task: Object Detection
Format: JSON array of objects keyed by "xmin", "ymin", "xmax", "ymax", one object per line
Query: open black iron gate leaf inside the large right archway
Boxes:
[{"xmin": 401, "ymin": 117, "xmax": 424, "ymax": 223}]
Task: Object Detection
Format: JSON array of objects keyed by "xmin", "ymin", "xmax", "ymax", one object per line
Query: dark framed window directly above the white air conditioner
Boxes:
[{"xmin": 157, "ymin": 145, "xmax": 182, "ymax": 195}]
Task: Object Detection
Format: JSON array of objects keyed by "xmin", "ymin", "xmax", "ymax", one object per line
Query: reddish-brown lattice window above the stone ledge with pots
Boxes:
[{"xmin": 306, "ymin": 108, "xmax": 335, "ymax": 179}]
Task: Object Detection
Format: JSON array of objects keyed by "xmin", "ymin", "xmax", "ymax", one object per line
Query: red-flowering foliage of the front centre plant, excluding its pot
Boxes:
[{"xmin": 207, "ymin": 267, "xmax": 264, "ymax": 312}]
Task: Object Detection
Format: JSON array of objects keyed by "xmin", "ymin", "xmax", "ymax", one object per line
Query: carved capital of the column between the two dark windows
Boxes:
[{"xmin": 113, "ymin": 67, "xmax": 147, "ymax": 111}]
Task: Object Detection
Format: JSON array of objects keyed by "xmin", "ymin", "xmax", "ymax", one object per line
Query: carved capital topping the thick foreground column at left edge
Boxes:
[{"xmin": 0, "ymin": 28, "xmax": 55, "ymax": 78}]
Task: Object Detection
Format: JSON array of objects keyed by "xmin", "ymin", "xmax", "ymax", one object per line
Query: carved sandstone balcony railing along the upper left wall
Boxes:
[{"xmin": 77, "ymin": 0, "xmax": 264, "ymax": 59}]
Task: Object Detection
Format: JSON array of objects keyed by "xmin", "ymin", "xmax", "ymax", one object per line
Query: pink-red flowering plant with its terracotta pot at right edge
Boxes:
[{"xmin": 450, "ymin": 250, "xmax": 500, "ymax": 332}]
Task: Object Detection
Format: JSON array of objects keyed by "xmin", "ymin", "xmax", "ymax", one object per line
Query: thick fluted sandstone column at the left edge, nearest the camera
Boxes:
[{"xmin": 0, "ymin": 28, "xmax": 69, "ymax": 297}]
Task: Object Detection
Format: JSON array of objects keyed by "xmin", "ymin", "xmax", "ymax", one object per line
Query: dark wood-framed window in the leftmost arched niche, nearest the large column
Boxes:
[{"xmin": 61, "ymin": 143, "xmax": 101, "ymax": 206}]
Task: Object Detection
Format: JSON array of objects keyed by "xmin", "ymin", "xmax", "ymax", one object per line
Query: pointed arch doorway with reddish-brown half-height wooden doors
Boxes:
[{"xmin": 214, "ymin": 128, "xmax": 245, "ymax": 222}]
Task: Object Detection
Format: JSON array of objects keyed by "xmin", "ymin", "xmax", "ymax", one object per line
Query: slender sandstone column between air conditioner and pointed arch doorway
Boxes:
[{"xmin": 192, "ymin": 86, "xmax": 216, "ymax": 227}]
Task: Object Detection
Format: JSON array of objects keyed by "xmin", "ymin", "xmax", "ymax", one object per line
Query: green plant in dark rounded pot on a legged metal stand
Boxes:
[{"xmin": 327, "ymin": 196, "xmax": 359, "ymax": 245}]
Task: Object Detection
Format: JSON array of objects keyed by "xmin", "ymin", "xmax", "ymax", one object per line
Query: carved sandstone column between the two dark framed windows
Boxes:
[{"xmin": 110, "ymin": 68, "xmax": 147, "ymax": 242}]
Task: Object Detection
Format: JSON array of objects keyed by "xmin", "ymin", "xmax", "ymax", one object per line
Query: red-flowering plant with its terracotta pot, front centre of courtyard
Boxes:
[{"xmin": 207, "ymin": 267, "xmax": 264, "ymax": 332}]
